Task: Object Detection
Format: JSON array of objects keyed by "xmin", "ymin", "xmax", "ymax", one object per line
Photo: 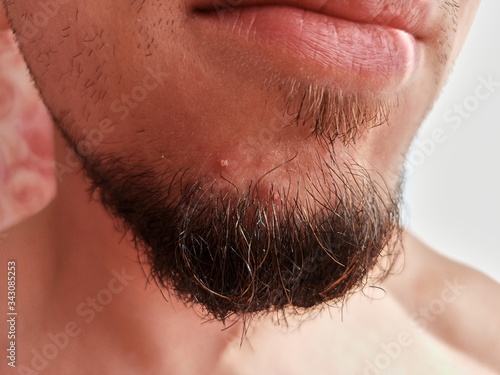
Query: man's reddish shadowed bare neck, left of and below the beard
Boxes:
[{"xmin": 6, "ymin": 131, "xmax": 241, "ymax": 374}]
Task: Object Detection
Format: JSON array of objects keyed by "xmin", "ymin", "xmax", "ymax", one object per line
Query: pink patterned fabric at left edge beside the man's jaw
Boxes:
[{"xmin": 0, "ymin": 31, "xmax": 56, "ymax": 231}]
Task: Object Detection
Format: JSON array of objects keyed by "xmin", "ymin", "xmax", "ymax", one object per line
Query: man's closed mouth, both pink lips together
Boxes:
[{"xmin": 192, "ymin": 0, "xmax": 433, "ymax": 94}]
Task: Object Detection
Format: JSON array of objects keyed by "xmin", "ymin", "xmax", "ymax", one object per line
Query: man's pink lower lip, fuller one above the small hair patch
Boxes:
[{"xmin": 193, "ymin": 6, "xmax": 420, "ymax": 92}]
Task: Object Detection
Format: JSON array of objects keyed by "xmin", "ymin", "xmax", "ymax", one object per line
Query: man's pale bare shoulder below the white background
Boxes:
[{"xmin": 385, "ymin": 234, "xmax": 500, "ymax": 373}]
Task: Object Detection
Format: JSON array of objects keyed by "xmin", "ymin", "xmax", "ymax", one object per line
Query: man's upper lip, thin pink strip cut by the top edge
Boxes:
[{"xmin": 192, "ymin": 0, "xmax": 439, "ymax": 38}]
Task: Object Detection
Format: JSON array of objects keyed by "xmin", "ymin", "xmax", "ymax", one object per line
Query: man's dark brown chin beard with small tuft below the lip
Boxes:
[{"xmin": 55, "ymin": 81, "xmax": 402, "ymax": 321}]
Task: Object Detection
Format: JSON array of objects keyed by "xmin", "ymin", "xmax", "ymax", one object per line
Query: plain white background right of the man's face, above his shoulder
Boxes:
[{"xmin": 405, "ymin": 0, "xmax": 500, "ymax": 281}]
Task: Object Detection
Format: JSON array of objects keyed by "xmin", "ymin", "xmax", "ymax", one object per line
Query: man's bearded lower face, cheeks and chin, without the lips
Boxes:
[{"xmin": 5, "ymin": 0, "xmax": 478, "ymax": 319}]
